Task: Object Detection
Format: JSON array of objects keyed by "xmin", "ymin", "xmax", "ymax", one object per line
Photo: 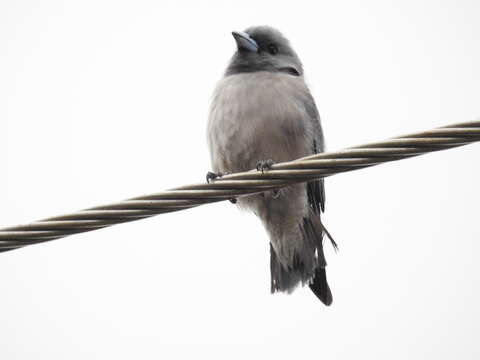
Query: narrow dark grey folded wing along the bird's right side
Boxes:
[{"xmin": 304, "ymin": 94, "xmax": 325, "ymax": 215}]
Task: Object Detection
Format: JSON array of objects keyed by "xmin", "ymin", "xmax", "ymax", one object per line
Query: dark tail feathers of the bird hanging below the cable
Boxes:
[{"xmin": 270, "ymin": 213, "xmax": 336, "ymax": 306}]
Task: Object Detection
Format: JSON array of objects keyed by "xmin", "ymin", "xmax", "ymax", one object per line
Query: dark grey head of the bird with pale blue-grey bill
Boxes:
[{"xmin": 226, "ymin": 26, "xmax": 303, "ymax": 76}]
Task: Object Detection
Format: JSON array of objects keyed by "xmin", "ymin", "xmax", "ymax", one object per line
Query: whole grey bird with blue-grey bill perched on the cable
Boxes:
[{"xmin": 207, "ymin": 26, "xmax": 336, "ymax": 305}]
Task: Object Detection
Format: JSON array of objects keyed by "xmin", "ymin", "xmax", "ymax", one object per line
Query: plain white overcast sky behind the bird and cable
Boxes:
[{"xmin": 0, "ymin": 0, "xmax": 480, "ymax": 359}]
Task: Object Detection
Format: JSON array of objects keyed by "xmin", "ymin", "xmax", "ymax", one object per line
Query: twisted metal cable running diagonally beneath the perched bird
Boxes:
[{"xmin": 0, "ymin": 120, "xmax": 480, "ymax": 252}]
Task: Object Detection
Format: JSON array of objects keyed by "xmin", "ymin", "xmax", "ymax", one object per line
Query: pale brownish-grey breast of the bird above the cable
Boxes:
[{"xmin": 208, "ymin": 72, "xmax": 312, "ymax": 172}]
